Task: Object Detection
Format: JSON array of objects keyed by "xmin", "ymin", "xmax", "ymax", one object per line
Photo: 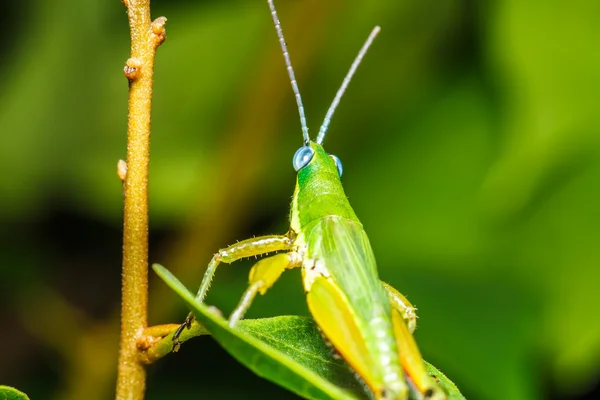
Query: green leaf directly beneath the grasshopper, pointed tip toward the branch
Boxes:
[{"xmin": 153, "ymin": 264, "xmax": 464, "ymax": 400}]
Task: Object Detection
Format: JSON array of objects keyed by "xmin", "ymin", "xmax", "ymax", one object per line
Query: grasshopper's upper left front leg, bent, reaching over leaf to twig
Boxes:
[{"xmin": 173, "ymin": 232, "xmax": 294, "ymax": 351}]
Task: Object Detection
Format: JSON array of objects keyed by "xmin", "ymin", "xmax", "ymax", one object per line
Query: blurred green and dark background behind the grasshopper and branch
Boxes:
[{"xmin": 0, "ymin": 0, "xmax": 600, "ymax": 400}]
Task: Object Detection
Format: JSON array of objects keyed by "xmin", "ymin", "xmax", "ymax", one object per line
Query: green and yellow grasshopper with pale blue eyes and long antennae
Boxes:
[{"xmin": 173, "ymin": 0, "xmax": 446, "ymax": 400}]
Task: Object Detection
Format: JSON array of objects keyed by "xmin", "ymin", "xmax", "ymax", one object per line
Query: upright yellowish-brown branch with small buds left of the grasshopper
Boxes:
[{"xmin": 116, "ymin": 0, "xmax": 166, "ymax": 400}]
